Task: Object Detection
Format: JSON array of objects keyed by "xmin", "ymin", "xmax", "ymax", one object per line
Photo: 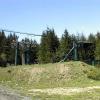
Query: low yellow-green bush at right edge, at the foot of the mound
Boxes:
[{"xmin": 86, "ymin": 68, "xmax": 100, "ymax": 80}]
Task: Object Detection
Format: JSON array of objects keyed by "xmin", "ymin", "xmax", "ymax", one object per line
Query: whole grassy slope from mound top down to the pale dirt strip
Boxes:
[{"xmin": 0, "ymin": 62, "xmax": 100, "ymax": 98}]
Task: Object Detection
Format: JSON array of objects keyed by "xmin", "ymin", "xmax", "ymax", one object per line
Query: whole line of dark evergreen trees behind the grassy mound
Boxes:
[{"xmin": 0, "ymin": 28, "xmax": 100, "ymax": 65}]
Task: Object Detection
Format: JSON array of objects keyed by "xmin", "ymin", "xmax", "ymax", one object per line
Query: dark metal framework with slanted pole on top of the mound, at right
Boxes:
[{"xmin": 60, "ymin": 41, "xmax": 95, "ymax": 65}]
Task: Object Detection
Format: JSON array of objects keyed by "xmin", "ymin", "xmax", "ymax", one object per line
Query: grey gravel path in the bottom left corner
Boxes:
[{"xmin": 0, "ymin": 86, "xmax": 31, "ymax": 100}]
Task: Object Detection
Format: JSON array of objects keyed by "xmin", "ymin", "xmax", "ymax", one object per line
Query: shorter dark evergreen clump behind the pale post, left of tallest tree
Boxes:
[{"xmin": 19, "ymin": 38, "xmax": 39, "ymax": 64}]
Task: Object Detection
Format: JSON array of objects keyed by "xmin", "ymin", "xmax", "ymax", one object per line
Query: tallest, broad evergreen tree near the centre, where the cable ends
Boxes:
[{"xmin": 39, "ymin": 28, "xmax": 59, "ymax": 63}]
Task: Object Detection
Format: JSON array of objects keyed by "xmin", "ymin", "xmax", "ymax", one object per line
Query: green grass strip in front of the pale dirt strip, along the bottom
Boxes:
[{"xmin": 32, "ymin": 89, "xmax": 100, "ymax": 100}]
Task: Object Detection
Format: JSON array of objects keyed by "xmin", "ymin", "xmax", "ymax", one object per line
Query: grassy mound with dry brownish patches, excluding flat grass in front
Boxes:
[{"xmin": 0, "ymin": 61, "xmax": 91, "ymax": 87}]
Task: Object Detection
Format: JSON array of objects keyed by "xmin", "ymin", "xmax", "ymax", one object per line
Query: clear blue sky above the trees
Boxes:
[{"xmin": 0, "ymin": 0, "xmax": 100, "ymax": 41}]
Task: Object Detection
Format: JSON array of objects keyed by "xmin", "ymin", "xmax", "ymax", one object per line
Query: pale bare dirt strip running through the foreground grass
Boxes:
[{"xmin": 28, "ymin": 86, "xmax": 100, "ymax": 95}]
